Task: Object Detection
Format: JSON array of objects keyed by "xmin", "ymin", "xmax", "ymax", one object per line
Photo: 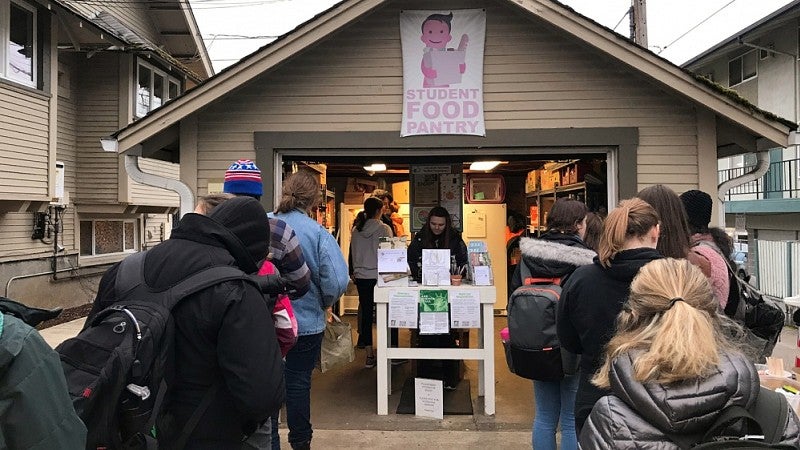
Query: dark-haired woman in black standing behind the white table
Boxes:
[{"xmin": 408, "ymin": 206, "xmax": 467, "ymax": 390}]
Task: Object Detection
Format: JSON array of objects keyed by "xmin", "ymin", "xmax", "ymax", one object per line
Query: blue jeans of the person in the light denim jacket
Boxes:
[{"xmin": 271, "ymin": 333, "xmax": 323, "ymax": 450}]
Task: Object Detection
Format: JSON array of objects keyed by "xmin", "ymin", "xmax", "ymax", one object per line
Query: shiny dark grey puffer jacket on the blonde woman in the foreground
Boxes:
[{"xmin": 580, "ymin": 353, "xmax": 800, "ymax": 450}]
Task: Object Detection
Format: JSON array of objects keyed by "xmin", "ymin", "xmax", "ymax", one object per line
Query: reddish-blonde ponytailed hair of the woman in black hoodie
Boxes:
[{"xmin": 597, "ymin": 198, "xmax": 658, "ymax": 267}]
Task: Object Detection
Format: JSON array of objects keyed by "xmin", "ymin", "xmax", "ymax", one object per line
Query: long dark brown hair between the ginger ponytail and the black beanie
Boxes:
[{"xmin": 636, "ymin": 184, "xmax": 690, "ymax": 258}]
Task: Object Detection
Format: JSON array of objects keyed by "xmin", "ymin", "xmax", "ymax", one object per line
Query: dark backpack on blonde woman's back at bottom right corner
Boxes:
[{"xmin": 666, "ymin": 387, "xmax": 796, "ymax": 450}]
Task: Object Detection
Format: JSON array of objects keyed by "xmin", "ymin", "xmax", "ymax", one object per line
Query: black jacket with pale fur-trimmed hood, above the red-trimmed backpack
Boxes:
[{"xmin": 508, "ymin": 232, "xmax": 596, "ymax": 295}]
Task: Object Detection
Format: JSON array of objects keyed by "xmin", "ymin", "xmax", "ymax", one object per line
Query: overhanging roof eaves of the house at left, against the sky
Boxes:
[{"xmin": 54, "ymin": 0, "xmax": 214, "ymax": 83}]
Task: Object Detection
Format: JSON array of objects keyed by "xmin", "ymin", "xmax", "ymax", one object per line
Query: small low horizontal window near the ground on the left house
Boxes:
[{"xmin": 81, "ymin": 219, "xmax": 139, "ymax": 256}]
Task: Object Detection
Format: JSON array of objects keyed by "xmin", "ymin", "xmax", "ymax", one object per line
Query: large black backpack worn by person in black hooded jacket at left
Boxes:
[{"xmin": 56, "ymin": 252, "xmax": 257, "ymax": 450}]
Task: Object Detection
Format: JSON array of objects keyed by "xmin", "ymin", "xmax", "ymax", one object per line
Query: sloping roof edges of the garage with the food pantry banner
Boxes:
[{"xmin": 113, "ymin": 0, "xmax": 796, "ymax": 152}]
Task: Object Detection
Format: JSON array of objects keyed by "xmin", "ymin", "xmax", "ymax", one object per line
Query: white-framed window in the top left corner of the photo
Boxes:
[{"xmin": 0, "ymin": 0, "xmax": 38, "ymax": 87}]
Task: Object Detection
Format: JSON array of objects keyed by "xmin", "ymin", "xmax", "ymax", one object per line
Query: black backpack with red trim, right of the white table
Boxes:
[{"xmin": 503, "ymin": 261, "xmax": 577, "ymax": 381}]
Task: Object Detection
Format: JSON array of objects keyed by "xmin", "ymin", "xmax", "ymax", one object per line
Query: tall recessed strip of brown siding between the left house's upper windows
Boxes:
[{"xmin": 73, "ymin": 53, "xmax": 120, "ymax": 204}]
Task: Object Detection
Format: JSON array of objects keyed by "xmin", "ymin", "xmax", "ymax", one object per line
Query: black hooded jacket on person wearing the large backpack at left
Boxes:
[{"xmin": 90, "ymin": 197, "xmax": 285, "ymax": 449}]
